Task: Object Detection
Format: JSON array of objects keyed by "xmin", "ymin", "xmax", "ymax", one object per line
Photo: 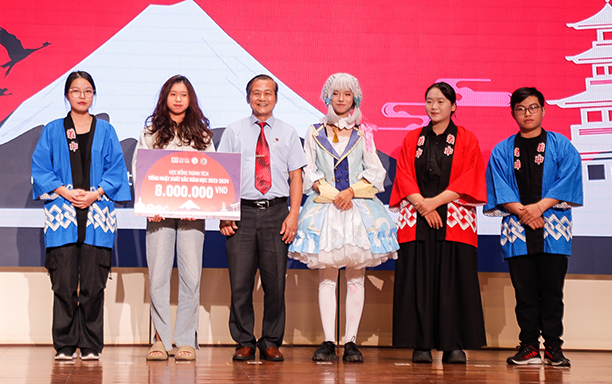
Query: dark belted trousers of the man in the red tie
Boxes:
[{"xmin": 226, "ymin": 203, "xmax": 289, "ymax": 350}]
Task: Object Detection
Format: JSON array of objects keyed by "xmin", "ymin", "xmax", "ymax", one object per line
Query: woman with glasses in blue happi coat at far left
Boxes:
[{"xmin": 32, "ymin": 71, "xmax": 131, "ymax": 360}]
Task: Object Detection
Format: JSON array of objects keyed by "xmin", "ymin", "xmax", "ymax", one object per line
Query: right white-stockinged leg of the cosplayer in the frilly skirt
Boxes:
[{"xmin": 344, "ymin": 267, "xmax": 365, "ymax": 343}]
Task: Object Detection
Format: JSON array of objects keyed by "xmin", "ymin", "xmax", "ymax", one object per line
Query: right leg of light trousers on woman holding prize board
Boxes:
[{"xmin": 174, "ymin": 220, "xmax": 204, "ymax": 349}]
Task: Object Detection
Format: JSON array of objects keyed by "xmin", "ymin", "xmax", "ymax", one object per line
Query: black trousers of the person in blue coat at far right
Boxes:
[{"xmin": 507, "ymin": 253, "xmax": 567, "ymax": 349}]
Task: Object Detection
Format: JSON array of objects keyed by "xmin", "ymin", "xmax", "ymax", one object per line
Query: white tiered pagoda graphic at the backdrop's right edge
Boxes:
[{"xmin": 548, "ymin": 0, "xmax": 612, "ymax": 237}]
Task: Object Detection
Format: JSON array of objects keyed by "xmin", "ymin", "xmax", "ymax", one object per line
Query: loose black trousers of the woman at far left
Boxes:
[{"xmin": 45, "ymin": 243, "xmax": 112, "ymax": 353}]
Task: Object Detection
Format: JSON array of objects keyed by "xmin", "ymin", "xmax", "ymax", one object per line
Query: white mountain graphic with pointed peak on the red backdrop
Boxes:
[{"xmin": 0, "ymin": 1, "xmax": 322, "ymax": 144}]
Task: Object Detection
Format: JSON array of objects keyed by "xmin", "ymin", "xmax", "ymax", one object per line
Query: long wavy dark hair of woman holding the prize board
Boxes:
[{"xmin": 146, "ymin": 75, "xmax": 212, "ymax": 151}]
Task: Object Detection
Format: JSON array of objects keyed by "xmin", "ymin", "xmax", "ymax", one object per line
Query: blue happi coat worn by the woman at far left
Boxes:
[{"xmin": 32, "ymin": 119, "xmax": 131, "ymax": 248}]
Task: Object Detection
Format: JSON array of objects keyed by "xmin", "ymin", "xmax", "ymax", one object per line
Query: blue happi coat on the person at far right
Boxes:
[{"xmin": 483, "ymin": 131, "xmax": 583, "ymax": 259}]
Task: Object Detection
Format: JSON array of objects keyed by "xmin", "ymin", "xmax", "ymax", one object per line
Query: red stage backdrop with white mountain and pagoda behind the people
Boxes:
[{"xmin": 0, "ymin": 0, "xmax": 612, "ymax": 274}]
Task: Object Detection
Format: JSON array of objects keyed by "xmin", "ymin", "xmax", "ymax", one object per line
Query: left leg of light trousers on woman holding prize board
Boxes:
[{"xmin": 146, "ymin": 219, "xmax": 179, "ymax": 351}]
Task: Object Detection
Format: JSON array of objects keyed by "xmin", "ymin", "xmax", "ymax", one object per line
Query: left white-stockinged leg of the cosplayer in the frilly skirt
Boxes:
[{"xmin": 319, "ymin": 267, "xmax": 338, "ymax": 343}]
